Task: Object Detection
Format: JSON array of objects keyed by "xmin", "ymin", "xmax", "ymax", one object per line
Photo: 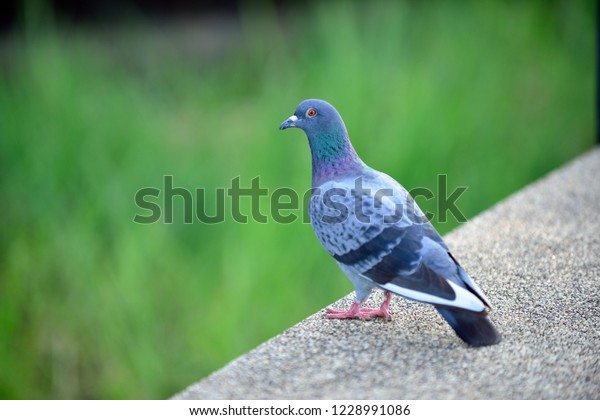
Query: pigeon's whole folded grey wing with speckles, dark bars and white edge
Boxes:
[{"xmin": 309, "ymin": 171, "xmax": 489, "ymax": 312}]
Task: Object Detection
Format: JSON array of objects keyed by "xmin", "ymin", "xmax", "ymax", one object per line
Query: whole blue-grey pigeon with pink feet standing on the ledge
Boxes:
[{"xmin": 279, "ymin": 99, "xmax": 502, "ymax": 347}]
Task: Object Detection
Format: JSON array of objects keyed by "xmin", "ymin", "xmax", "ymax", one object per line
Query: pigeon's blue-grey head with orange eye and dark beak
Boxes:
[{"xmin": 279, "ymin": 99, "xmax": 346, "ymax": 138}]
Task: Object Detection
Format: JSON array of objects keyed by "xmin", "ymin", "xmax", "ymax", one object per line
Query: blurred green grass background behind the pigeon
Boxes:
[{"xmin": 0, "ymin": 1, "xmax": 596, "ymax": 398}]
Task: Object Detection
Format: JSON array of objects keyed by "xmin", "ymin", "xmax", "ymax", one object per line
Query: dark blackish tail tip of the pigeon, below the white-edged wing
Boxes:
[{"xmin": 436, "ymin": 307, "xmax": 502, "ymax": 347}]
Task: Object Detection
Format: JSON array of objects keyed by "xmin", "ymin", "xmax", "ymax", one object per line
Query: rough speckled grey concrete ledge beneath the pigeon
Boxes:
[{"xmin": 174, "ymin": 148, "xmax": 600, "ymax": 399}]
